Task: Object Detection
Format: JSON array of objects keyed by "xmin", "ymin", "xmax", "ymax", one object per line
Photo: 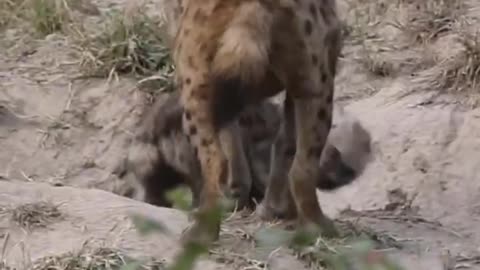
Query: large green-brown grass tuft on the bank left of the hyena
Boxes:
[{"xmin": 75, "ymin": 6, "xmax": 173, "ymax": 87}]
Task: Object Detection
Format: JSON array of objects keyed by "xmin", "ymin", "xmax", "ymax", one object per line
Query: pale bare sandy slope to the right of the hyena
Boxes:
[{"xmin": 321, "ymin": 89, "xmax": 480, "ymax": 269}]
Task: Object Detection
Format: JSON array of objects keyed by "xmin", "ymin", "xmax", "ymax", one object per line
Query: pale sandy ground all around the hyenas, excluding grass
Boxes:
[{"xmin": 0, "ymin": 1, "xmax": 480, "ymax": 270}]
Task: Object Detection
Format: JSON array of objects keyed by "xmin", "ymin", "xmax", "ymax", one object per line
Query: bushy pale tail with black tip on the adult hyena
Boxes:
[{"xmin": 211, "ymin": 1, "xmax": 274, "ymax": 128}]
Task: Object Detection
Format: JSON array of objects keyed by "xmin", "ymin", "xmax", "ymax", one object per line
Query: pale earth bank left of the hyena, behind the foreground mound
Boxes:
[{"xmin": 0, "ymin": 30, "xmax": 146, "ymax": 192}]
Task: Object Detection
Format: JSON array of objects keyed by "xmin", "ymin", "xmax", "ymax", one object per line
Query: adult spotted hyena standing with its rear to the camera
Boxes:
[{"xmin": 173, "ymin": 0, "xmax": 342, "ymax": 242}]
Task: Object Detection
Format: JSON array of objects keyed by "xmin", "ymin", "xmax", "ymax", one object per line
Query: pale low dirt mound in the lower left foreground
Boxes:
[{"xmin": 0, "ymin": 182, "xmax": 220, "ymax": 269}]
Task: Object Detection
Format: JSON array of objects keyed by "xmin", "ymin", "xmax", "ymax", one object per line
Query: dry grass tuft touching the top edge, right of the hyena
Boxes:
[{"xmin": 394, "ymin": 0, "xmax": 465, "ymax": 44}]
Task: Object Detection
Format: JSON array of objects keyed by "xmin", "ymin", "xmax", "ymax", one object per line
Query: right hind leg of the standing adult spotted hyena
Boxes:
[{"xmin": 288, "ymin": 84, "xmax": 338, "ymax": 236}]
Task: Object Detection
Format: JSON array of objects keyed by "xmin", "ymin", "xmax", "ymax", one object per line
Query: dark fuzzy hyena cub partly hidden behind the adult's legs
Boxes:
[{"xmin": 122, "ymin": 93, "xmax": 371, "ymax": 215}]
